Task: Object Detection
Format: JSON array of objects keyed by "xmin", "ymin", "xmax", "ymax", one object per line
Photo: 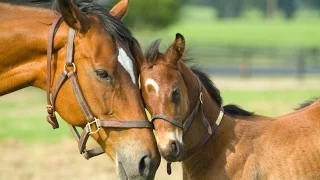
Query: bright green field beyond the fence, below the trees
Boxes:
[{"xmin": 134, "ymin": 6, "xmax": 320, "ymax": 48}]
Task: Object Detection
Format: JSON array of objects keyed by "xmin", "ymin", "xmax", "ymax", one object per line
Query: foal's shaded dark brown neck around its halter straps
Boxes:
[{"xmin": 182, "ymin": 62, "xmax": 235, "ymax": 179}]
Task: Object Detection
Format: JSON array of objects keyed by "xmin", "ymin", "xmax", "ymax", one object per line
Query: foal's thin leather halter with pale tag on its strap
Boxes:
[{"xmin": 151, "ymin": 78, "xmax": 224, "ymax": 175}]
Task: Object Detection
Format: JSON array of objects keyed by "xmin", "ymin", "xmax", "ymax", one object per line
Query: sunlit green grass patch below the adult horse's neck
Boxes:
[{"xmin": 0, "ymin": 88, "xmax": 71, "ymax": 142}]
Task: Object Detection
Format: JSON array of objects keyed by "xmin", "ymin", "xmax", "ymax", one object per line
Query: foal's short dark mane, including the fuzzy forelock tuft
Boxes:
[{"xmin": 145, "ymin": 39, "xmax": 254, "ymax": 116}]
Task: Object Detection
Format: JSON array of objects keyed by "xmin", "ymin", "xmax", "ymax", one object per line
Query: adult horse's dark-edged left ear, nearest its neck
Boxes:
[{"xmin": 59, "ymin": 0, "xmax": 90, "ymax": 33}]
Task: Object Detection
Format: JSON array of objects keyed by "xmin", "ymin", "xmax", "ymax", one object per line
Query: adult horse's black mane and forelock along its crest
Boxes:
[{"xmin": 2, "ymin": 0, "xmax": 138, "ymax": 49}]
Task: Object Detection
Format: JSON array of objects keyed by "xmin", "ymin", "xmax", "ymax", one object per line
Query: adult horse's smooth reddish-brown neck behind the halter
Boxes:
[{"xmin": 0, "ymin": 3, "xmax": 68, "ymax": 95}]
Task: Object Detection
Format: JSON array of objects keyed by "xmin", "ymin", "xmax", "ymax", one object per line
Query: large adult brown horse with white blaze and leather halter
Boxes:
[{"xmin": 0, "ymin": 0, "xmax": 160, "ymax": 179}]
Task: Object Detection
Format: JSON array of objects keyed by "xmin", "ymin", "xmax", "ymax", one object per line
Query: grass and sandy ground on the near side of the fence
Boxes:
[{"xmin": 0, "ymin": 76, "xmax": 320, "ymax": 180}]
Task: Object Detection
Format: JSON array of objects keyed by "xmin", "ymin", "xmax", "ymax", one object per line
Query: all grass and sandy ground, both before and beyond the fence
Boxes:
[{"xmin": 0, "ymin": 3, "xmax": 320, "ymax": 180}]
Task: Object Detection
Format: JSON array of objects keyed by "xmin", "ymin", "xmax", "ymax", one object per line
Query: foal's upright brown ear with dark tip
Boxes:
[{"xmin": 165, "ymin": 33, "xmax": 186, "ymax": 64}]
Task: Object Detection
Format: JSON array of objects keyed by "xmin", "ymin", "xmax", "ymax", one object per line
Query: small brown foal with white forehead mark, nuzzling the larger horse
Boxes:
[{"xmin": 140, "ymin": 34, "xmax": 320, "ymax": 180}]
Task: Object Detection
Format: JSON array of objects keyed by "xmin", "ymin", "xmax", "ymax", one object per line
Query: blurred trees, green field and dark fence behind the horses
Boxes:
[{"xmin": 107, "ymin": 0, "xmax": 320, "ymax": 78}]
